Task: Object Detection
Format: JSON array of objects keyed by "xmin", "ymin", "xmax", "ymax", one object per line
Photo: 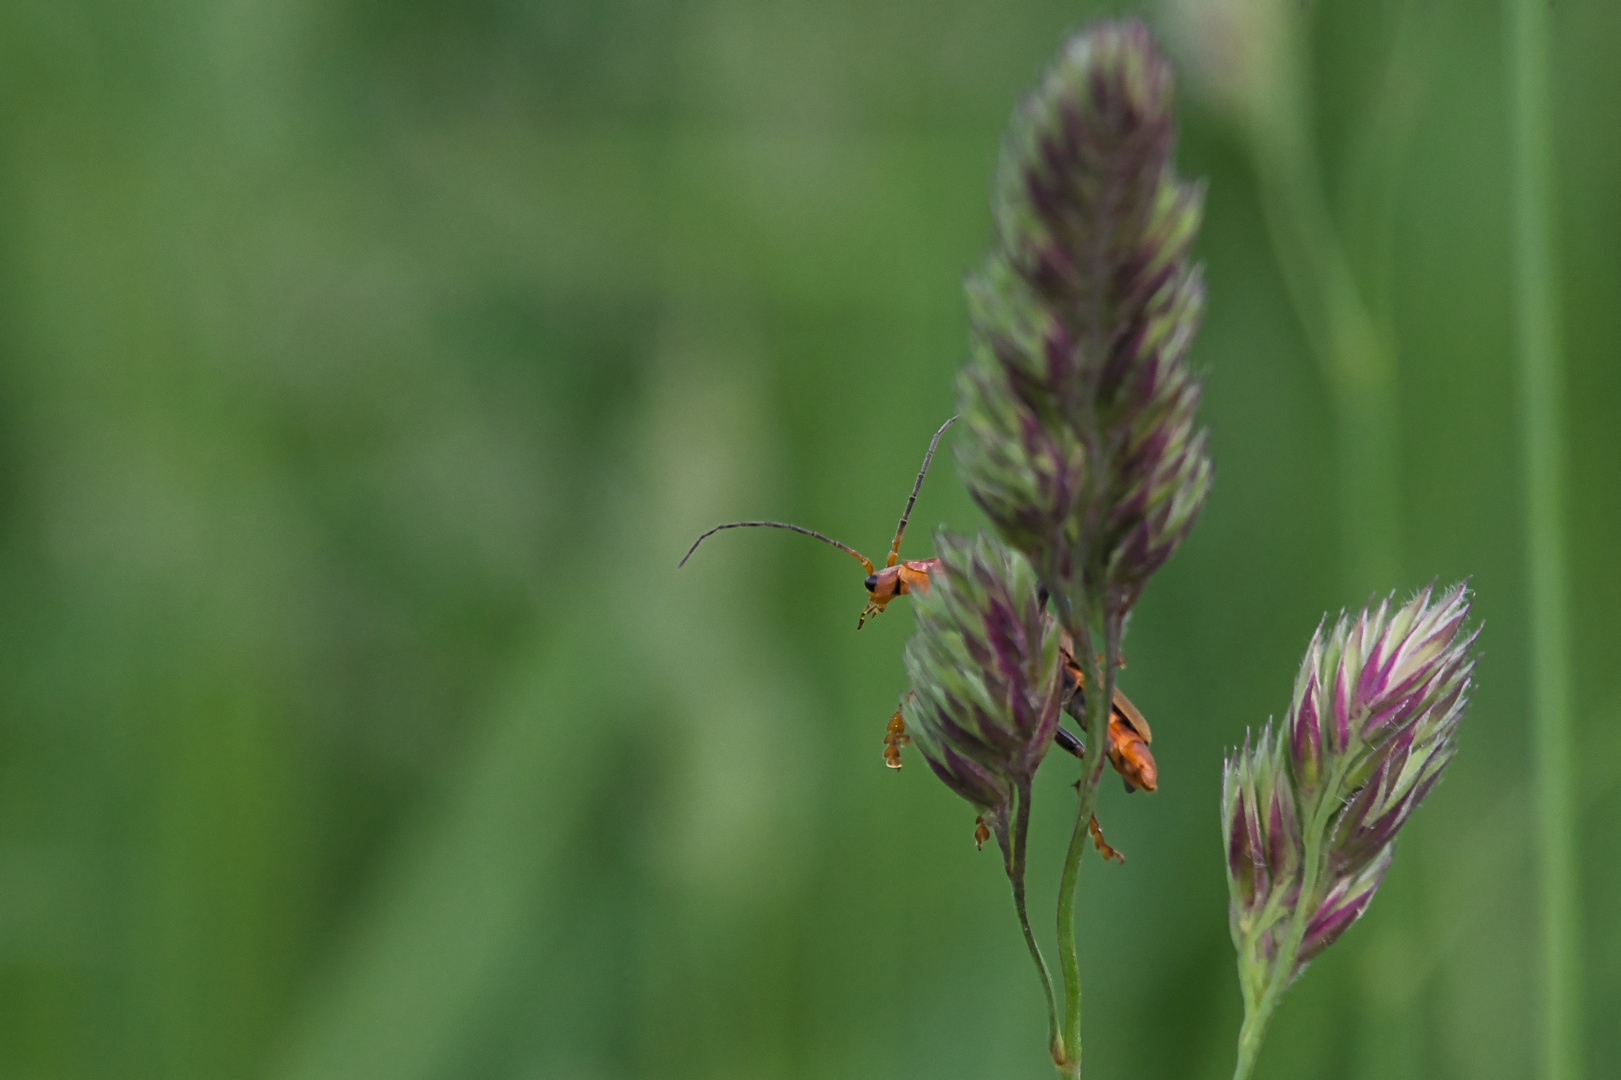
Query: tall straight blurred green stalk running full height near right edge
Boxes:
[{"xmin": 1504, "ymin": 0, "xmax": 1582, "ymax": 1080}]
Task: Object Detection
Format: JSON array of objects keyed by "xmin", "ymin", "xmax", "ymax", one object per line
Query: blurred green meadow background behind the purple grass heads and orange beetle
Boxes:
[{"xmin": 0, "ymin": 0, "xmax": 1621, "ymax": 1080}]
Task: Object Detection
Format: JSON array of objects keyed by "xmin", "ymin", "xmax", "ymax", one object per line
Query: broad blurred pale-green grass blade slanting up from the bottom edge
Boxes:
[{"xmin": 271, "ymin": 624, "xmax": 624, "ymax": 1080}]
